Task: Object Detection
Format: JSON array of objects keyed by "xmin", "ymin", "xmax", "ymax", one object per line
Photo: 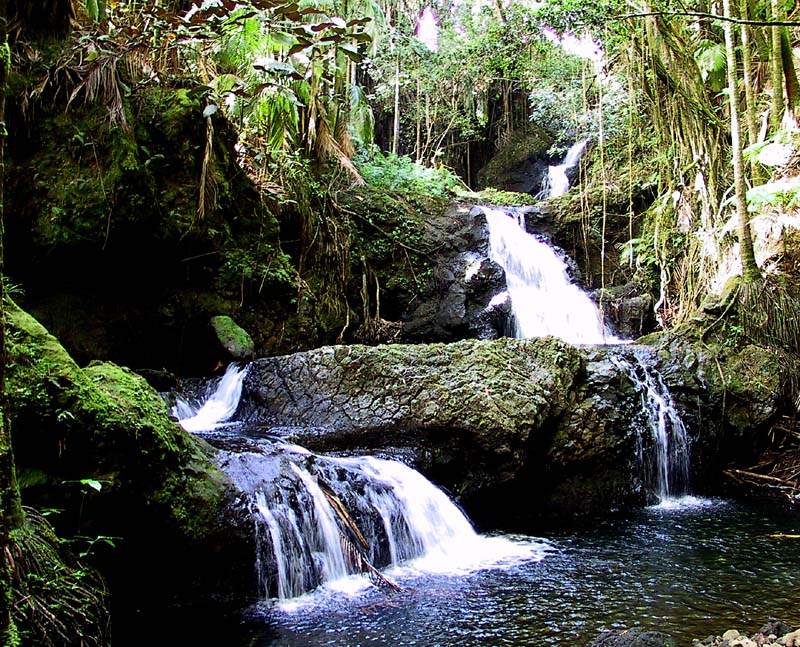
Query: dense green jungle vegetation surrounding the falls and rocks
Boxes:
[{"xmin": 0, "ymin": 0, "xmax": 800, "ymax": 645}]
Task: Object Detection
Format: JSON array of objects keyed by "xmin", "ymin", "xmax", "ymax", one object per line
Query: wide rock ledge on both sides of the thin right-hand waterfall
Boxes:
[{"xmin": 237, "ymin": 336, "xmax": 780, "ymax": 529}]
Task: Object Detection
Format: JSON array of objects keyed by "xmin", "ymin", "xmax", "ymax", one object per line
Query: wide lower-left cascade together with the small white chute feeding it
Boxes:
[{"xmin": 173, "ymin": 368, "xmax": 546, "ymax": 601}]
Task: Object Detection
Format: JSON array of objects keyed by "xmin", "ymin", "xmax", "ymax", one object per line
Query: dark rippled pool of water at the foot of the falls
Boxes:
[{"xmin": 239, "ymin": 501, "xmax": 800, "ymax": 647}]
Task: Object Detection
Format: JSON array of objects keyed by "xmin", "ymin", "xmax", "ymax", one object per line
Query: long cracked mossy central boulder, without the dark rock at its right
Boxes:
[{"xmin": 239, "ymin": 338, "xmax": 582, "ymax": 512}]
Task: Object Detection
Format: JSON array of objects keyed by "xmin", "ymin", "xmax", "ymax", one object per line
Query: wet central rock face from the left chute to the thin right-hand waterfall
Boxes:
[{"xmin": 238, "ymin": 338, "xmax": 668, "ymax": 528}]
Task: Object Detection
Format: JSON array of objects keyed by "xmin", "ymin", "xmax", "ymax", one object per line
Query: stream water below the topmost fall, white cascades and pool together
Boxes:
[{"xmin": 167, "ymin": 186, "xmax": 800, "ymax": 647}]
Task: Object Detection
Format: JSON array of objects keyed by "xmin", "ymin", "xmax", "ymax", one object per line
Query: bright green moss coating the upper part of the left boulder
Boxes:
[{"xmin": 8, "ymin": 305, "xmax": 230, "ymax": 541}]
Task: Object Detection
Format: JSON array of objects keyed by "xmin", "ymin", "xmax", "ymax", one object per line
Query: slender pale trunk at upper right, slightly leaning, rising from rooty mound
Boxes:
[{"xmin": 722, "ymin": 0, "xmax": 758, "ymax": 281}]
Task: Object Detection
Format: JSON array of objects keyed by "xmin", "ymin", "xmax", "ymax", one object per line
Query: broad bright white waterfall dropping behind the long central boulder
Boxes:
[{"xmin": 483, "ymin": 207, "xmax": 619, "ymax": 344}]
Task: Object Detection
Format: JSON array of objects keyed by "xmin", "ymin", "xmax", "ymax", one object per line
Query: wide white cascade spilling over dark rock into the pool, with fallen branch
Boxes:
[{"xmin": 256, "ymin": 446, "xmax": 546, "ymax": 608}]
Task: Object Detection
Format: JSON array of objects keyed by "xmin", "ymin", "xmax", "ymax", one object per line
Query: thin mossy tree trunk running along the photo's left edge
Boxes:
[{"xmin": 0, "ymin": 0, "xmax": 22, "ymax": 647}]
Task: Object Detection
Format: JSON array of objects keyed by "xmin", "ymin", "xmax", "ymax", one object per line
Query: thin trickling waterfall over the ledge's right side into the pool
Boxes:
[{"xmin": 613, "ymin": 348, "xmax": 690, "ymax": 504}]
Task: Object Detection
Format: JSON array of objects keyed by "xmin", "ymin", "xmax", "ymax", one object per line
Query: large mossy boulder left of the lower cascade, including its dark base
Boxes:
[{"xmin": 7, "ymin": 304, "xmax": 253, "ymax": 624}]
